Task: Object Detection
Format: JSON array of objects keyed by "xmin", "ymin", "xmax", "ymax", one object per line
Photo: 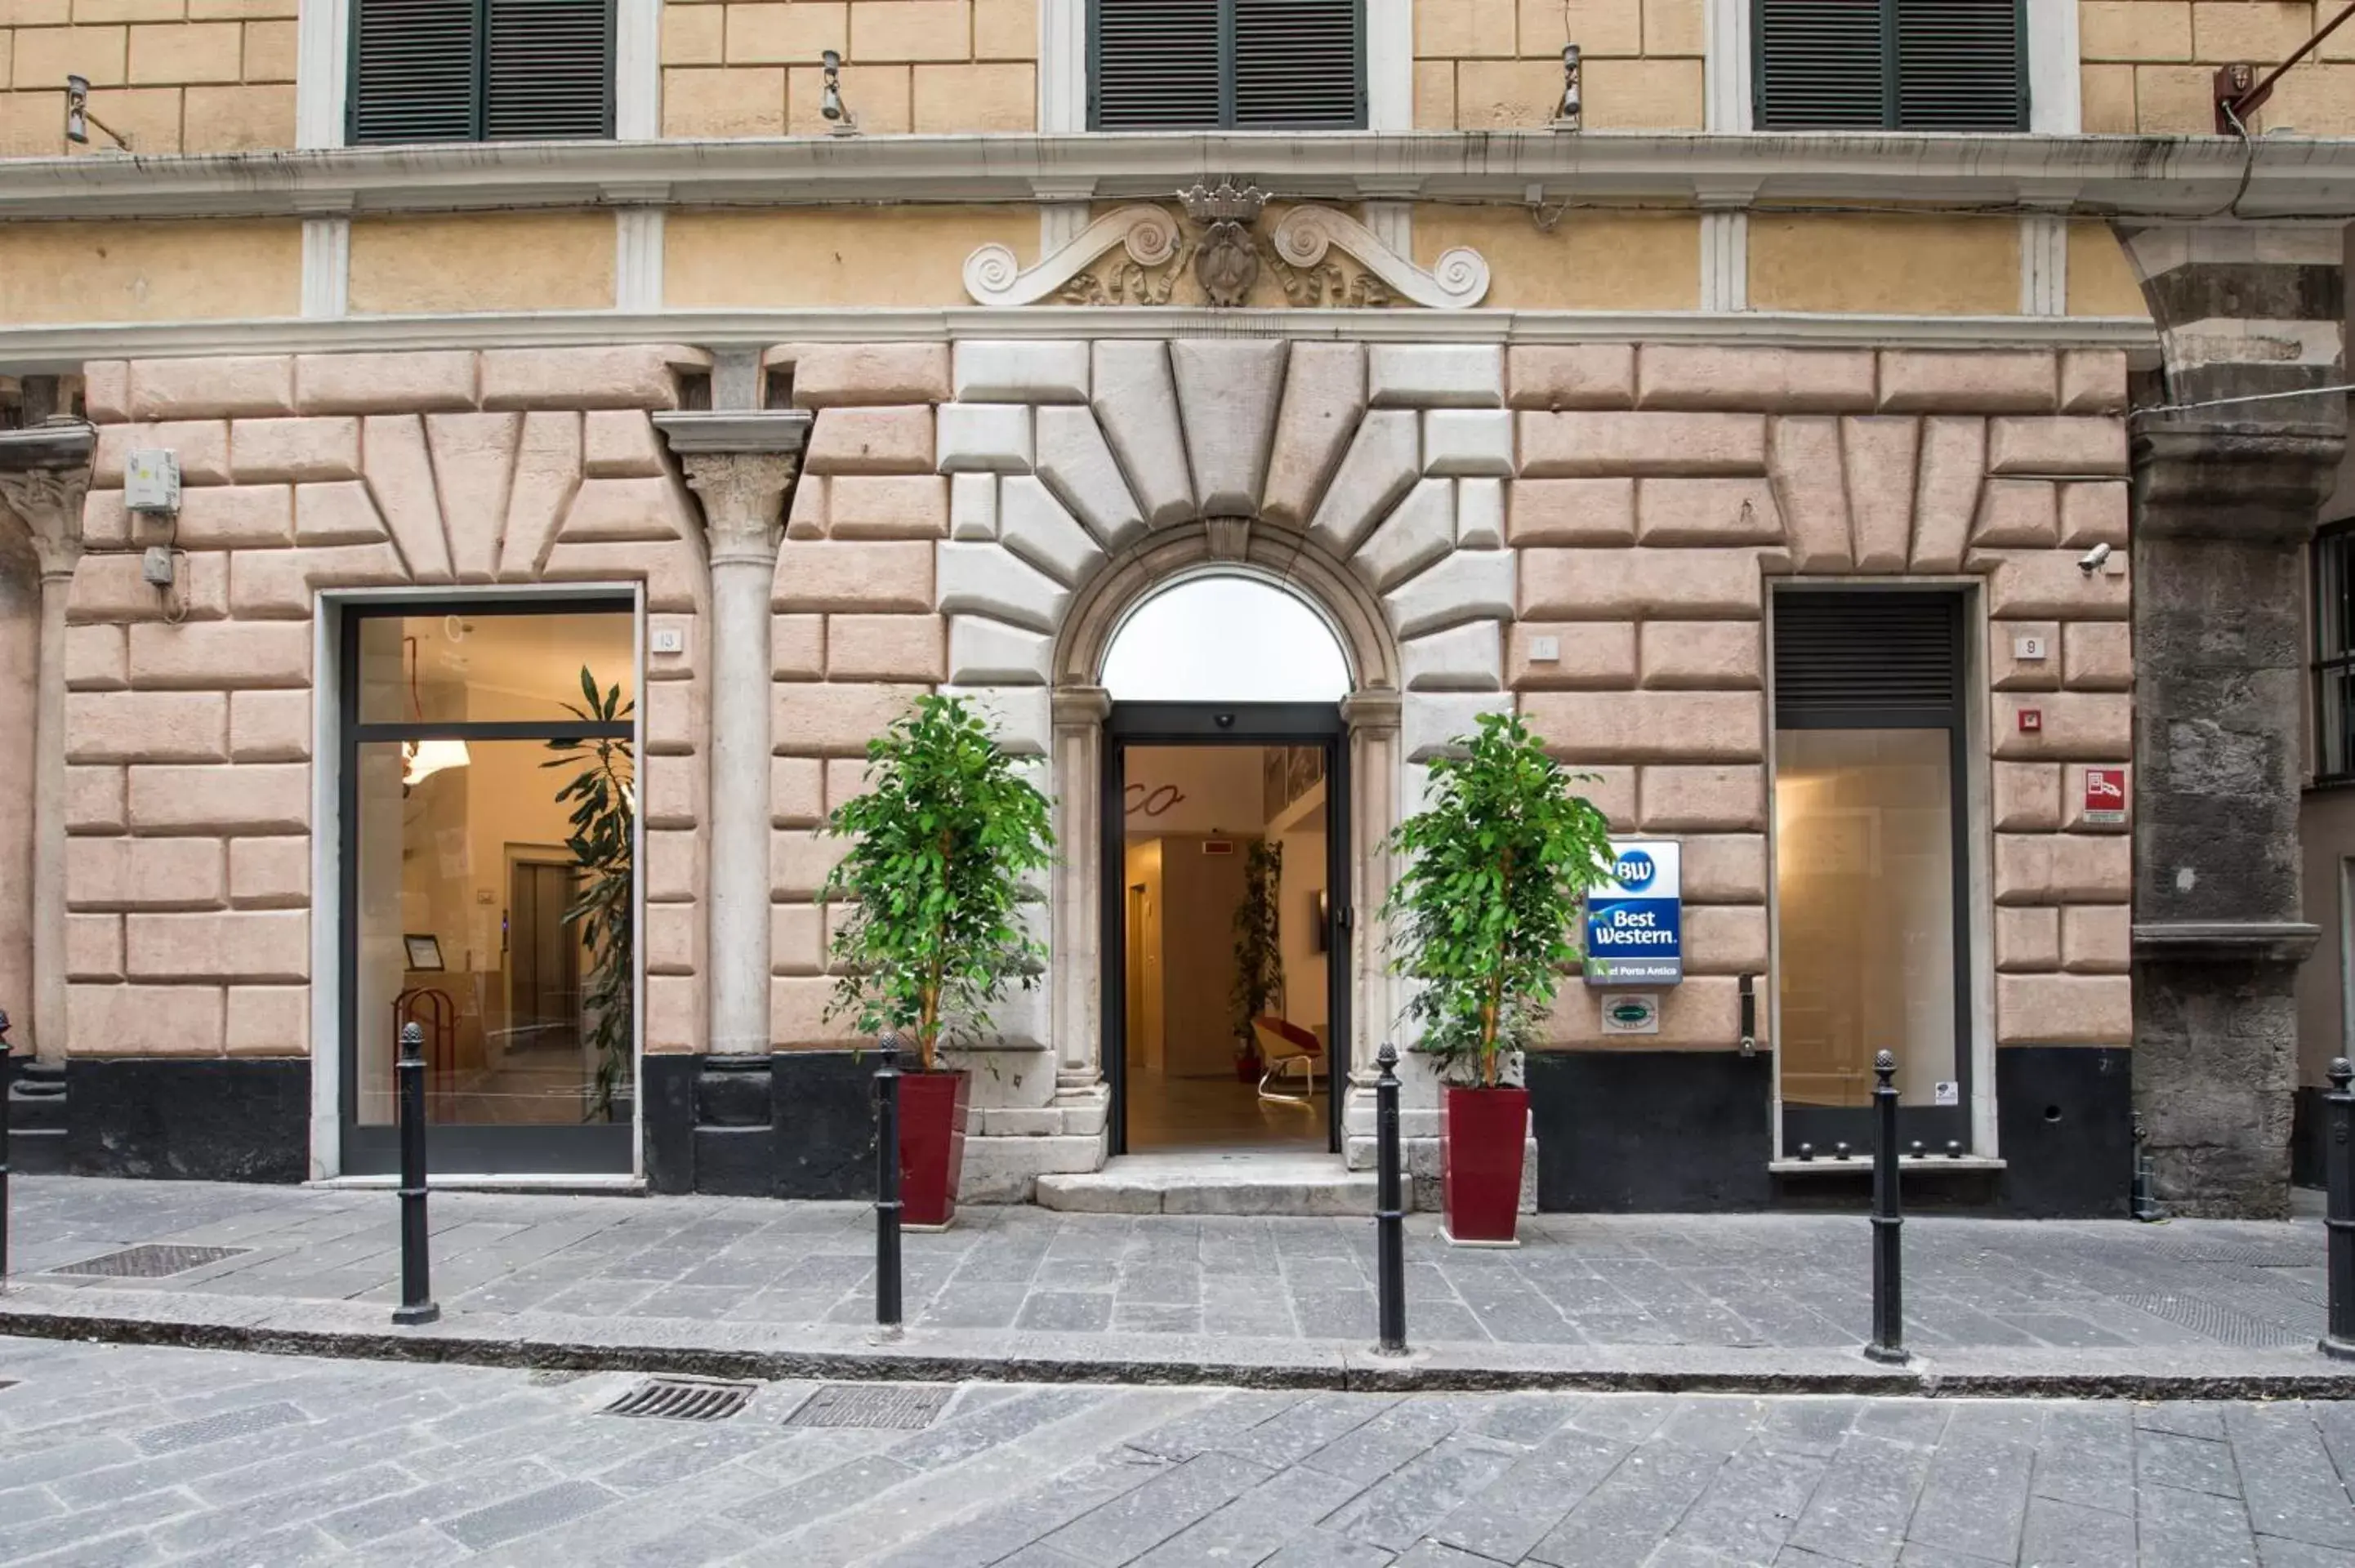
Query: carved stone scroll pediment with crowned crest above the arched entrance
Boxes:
[{"xmin": 966, "ymin": 181, "xmax": 1488, "ymax": 311}]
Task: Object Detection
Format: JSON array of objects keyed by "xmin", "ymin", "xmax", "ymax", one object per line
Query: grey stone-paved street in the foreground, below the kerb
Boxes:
[{"xmin": 0, "ymin": 1337, "xmax": 2355, "ymax": 1568}]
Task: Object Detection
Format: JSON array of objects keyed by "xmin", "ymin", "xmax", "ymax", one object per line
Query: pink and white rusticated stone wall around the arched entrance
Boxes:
[{"xmin": 773, "ymin": 339, "xmax": 2131, "ymax": 1186}]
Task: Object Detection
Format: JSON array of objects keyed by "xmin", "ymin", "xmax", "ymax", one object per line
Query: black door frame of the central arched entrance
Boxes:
[{"xmin": 1097, "ymin": 702, "xmax": 1357, "ymax": 1154}]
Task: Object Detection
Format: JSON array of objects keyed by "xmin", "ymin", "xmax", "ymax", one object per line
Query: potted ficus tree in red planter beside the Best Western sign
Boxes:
[{"xmin": 1382, "ymin": 714, "xmax": 1611, "ymax": 1245}]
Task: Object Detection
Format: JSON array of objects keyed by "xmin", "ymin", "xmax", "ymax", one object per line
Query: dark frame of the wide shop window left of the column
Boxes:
[{"xmin": 334, "ymin": 593, "xmax": 643, "ymax": 1175}]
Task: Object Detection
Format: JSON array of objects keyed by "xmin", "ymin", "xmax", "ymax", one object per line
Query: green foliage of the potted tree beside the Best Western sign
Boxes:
[{"xmin": 1382, "ymin": 714, "xmax": 1611, "ymax": 1088}]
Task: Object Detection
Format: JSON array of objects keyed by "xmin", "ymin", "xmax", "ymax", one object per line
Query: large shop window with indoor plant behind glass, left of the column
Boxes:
[{"xmin": 341, "ymin": 600, "xmax": 638, "ymax": 1173}]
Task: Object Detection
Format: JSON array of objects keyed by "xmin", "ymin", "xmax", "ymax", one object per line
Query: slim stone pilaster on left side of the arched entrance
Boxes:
[{"xmin": 1048, "ymin": 685, "xmax": 1112, "ymax": 1111}]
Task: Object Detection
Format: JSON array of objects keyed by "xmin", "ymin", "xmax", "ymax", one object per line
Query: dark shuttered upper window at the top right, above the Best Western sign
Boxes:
[{"xmin": 1755, "ymin": 0, "xmax": 2027, "ymax": 131}]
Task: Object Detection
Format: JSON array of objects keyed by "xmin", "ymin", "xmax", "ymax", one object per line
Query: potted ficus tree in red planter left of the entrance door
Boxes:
[{"xmin": 819, "ymin": 697, "xmax": 1055, "ymax": 1227}]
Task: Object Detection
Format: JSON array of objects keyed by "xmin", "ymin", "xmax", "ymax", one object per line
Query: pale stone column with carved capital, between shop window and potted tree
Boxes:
[{"xmin": 680, "ymin": 452, "xmax": 796, "ymax": 1055}]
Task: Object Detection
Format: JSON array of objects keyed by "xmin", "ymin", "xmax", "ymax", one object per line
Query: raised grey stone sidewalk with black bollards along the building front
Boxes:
[{"xmin": 11, "ymin": 1177, "xmax": 2331, "ymax": 1365}]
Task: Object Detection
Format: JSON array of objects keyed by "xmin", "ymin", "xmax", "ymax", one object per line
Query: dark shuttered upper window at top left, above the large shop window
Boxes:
[{"xmin": 346, "ymin": 0, "xmax": 613, "ymax": 144}]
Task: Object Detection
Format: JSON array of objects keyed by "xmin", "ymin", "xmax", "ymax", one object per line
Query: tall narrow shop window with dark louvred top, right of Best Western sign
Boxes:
[{"xmin": 1773, "ymin": 591, "xmax": 1971, "ymax": 1158}]
